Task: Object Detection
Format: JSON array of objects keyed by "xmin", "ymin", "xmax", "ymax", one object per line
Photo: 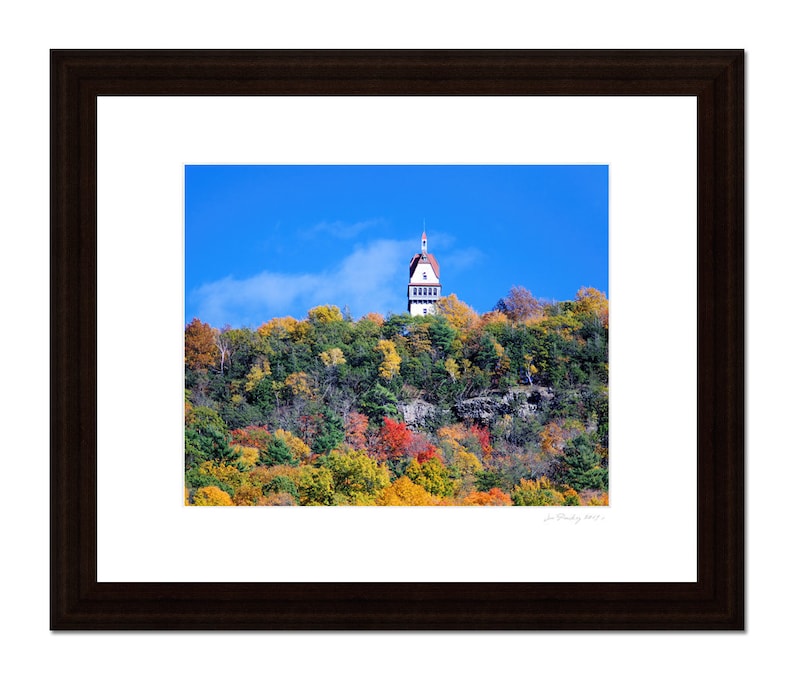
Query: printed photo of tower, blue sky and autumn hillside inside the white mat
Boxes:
[{"xmin": 184, "ymin": 165, "xmax": 609, "ymax": 507}]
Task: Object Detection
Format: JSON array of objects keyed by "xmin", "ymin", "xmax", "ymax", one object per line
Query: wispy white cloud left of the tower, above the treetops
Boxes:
[{"xmin": 188, "ymin": 240, "xmax": 414, "ymax": 326}]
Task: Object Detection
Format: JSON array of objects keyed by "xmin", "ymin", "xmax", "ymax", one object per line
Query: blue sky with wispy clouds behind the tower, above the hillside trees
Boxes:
[{"xmin": 185, "ymin": 165, "xmax": 609, "ymax": 327}]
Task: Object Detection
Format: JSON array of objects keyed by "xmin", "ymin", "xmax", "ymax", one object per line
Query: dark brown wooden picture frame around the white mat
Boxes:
[{"xmin": 50, "ymin": 50, "xmax": 744, "ymax": 630}]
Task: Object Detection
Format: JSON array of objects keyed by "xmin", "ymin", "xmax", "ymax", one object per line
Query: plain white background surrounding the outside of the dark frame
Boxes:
[{"xmin": 0, "ymin": 0, "xmax": 780, "ymax": 683}]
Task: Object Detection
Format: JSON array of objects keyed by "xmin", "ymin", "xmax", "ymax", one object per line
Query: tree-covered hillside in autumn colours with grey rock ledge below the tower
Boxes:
[{"xmin": 185, "ymin": 288, "xmax": 609, "ymax": 505}]
